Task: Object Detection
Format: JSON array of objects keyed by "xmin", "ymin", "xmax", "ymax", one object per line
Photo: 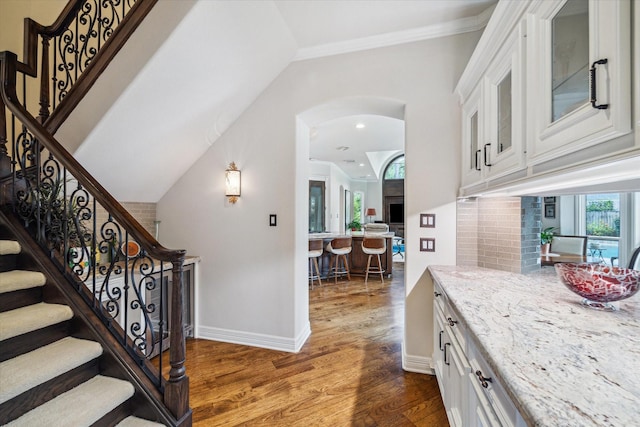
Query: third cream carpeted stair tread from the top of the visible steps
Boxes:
[{"xmin": 0, "ymin": 302, "xmax": 73, "ymax": 341}]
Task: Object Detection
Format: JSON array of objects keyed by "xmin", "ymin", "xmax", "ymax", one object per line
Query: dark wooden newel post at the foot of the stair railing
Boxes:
[{"xmin": 164, "ymin": 258, "xmax": 189, "ymax": 419}]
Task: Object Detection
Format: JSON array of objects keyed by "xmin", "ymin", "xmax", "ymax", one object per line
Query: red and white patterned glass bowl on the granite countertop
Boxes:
[{"xmin": 555, "ymin": 263, "xmax": 640, "ymax": 310}]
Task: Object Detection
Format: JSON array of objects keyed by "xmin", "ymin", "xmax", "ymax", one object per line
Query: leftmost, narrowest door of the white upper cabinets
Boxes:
[{"xmin": 462, "ymin": 85, "xmax": 484, "ymax": 186}]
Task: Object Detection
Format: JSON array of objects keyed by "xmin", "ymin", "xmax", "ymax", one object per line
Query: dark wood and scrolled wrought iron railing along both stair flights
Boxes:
[{"xmin": 0, "ymin": 0, "xmax": 191, "ymax": 425}]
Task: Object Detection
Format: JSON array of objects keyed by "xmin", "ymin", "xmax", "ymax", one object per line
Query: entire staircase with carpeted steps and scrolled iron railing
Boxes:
[{"xmin": 0, "ymin": 0, "xmax": 191, "ymax": 427}]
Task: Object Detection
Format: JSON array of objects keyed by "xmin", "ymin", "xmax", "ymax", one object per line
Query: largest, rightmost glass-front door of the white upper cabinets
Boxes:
[{"xmin": 527, "ymin": 0, "xmax": 631, "ymax": 164}]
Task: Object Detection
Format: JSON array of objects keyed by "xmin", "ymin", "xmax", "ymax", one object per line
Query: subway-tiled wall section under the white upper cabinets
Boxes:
[{"xmin": 457, "ymin": 197, "xmax": 542, "ymax": 273}]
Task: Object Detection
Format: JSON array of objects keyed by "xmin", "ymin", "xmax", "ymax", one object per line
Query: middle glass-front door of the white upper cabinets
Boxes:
[{"xmin": 481, "ymin": 21, "xmax": 526, "ymax": 179}]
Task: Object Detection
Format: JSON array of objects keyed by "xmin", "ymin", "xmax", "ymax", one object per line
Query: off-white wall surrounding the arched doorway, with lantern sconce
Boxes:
[{"xmin": 158, "ymin": 33, "xmax": 479, "ymax": 371}]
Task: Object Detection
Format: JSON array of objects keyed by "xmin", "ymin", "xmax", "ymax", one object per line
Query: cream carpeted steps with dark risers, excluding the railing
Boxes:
[{"xmin": 0, "ymin": 222, "xmax": 163, "ymax": 426}]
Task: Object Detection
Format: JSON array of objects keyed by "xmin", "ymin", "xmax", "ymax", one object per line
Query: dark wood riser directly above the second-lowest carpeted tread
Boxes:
[{"xmin": 0, "ymin": 359, "xmax": 100, "ymax": 425}]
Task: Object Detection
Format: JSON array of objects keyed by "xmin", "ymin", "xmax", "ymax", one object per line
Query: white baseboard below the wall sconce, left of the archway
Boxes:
[{"xmin": 196, "ymin": 322, "xmax": 311, "ymax": 353}]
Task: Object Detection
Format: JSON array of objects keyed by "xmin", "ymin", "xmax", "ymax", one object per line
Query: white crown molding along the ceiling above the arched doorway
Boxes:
[{"xmin": 293, "ymin": 6, "xmax": 495, "ymax": 61}]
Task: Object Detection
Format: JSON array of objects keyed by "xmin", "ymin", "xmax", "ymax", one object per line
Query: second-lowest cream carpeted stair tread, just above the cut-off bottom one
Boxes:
[{"xmin": 6, "ymin": 375, "xmax": 134, "ymax": 427}]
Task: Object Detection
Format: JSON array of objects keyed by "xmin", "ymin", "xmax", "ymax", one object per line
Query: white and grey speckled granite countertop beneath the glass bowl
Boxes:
[{"xmin": 429, "ymin": 266, "xmax": 640, "ymax": 427}]
